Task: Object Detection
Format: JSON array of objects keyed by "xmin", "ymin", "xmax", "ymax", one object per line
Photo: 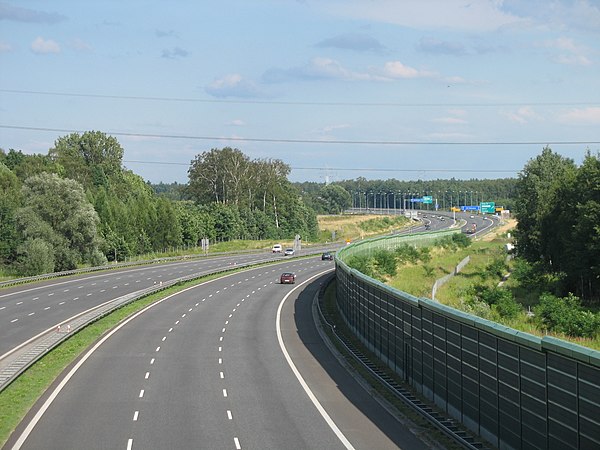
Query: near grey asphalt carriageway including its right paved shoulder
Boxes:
[{"xmin": 6, "ymin": 257, "xmax": 427, "ymax": 450}]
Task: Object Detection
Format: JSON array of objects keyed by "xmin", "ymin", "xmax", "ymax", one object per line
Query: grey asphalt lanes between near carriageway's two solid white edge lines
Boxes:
[{"xmin": 8, "ymin": 258, "xmax": 432, "ymax": 449}]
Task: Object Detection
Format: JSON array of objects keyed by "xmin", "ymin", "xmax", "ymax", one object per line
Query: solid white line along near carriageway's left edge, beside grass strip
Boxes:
[{"xmin": 12, "ymin": 274, "xmax": 235, "ymax": 450}]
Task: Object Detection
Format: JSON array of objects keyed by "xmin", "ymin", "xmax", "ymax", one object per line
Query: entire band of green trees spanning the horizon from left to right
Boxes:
[{"xmin": 0, "ymin": 131, "xmax": 600, "ymax": 302}]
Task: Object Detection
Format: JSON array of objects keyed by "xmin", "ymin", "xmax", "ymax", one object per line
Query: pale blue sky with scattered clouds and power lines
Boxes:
[{"xmin": 0, "ymin": 0, "xmax": 600, "ymax": 183}]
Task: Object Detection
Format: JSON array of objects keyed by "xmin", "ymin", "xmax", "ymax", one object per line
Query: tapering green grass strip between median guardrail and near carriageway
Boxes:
[{"xmin": 0, "ymin": 275, "xmax": 222, "ymax": 448}]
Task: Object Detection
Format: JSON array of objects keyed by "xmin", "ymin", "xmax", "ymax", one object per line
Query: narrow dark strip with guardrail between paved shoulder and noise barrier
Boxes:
[{"xmin": 315, "ymin": 277, "xmax": 488, "ymax": 450}]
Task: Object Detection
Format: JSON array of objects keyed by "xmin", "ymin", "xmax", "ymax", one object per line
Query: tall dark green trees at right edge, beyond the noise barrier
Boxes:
[{"xmin": 516, "ymin": 147, "xmax": 600, "ymax": 304}]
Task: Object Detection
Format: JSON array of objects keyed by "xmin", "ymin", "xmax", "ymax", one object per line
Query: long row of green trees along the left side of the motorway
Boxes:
[{"xmin": 0, "ymin": 131, "xmax": 318, "ymax": 275}]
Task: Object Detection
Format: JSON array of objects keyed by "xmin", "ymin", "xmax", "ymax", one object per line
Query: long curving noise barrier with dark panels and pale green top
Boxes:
[{"xmin": 336, "ymin": 231, "xmax": 600, "ymax": 449}]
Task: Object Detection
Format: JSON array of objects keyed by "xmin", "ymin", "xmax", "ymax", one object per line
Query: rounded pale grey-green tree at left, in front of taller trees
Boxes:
[{"xmin": 16, "ymin": 173, "xmax": 99, "ymax": 271}]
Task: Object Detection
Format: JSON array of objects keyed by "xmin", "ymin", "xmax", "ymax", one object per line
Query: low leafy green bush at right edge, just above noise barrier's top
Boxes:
[{"xmin": 534, "ymin": 294, "xmax": 600, "ymax": 338}]
